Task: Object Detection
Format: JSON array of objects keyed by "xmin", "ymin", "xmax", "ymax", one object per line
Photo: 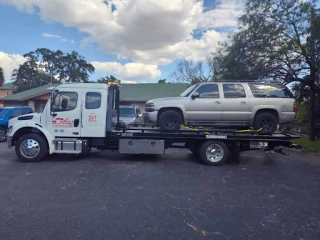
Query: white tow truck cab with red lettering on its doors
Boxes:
[{"xmin": 7, "ymin": 83, "xmax": 119, "ymax": 160}]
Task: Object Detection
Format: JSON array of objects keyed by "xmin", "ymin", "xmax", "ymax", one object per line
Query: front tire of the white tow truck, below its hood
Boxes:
[{"xmin": 15, "ymin": 133, "xmax": 48, "ymax": 162}]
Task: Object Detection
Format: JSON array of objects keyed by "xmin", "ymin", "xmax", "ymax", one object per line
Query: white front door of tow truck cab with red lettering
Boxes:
[{"xmin": 46, "ymin": 88, "xmax": 82, "ymax": 137}]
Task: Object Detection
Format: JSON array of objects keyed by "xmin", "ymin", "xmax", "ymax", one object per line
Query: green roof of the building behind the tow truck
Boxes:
[{"xmin": 0, "ymin": 83, "xmax": 189, "ymax": 102}]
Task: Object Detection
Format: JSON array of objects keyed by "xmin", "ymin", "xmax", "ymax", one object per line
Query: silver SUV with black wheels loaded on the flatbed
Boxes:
[{"xmin": 144, "ymin": 81, "xmax": 296, "ymax": 132}]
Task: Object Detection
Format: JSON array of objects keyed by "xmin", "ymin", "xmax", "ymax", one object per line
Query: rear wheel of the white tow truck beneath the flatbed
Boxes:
[{"xmin": 199, "ymin": 141, "xmax": 229, "ymax": 166}]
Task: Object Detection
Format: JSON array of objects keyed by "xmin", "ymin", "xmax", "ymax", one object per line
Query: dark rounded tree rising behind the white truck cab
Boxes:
[{"xmin": 12, "ymin": 48, "xmax": 94, "ymax": 91}]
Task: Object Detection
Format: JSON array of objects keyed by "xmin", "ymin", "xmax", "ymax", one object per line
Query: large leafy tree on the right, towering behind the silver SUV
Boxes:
[{"xmin": 216, "ymin": 0, "xmax": 320, "ymax": 141}]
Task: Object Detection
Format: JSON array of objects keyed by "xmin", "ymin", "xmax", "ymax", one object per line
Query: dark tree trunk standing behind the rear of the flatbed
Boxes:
[{"xmin": 309, "ymin": 69, "xmax": 316, "ymax": 142}]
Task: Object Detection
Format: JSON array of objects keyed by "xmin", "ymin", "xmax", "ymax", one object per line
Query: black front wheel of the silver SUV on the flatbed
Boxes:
[{"xmin": 158, "ymin": 110, "xmax": 183, "ymax": 130}]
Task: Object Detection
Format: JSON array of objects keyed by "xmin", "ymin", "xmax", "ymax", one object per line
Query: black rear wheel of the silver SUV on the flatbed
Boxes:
[{"xmin": 253, "ymin": 112, "xmax": 278, "ymax": 133}]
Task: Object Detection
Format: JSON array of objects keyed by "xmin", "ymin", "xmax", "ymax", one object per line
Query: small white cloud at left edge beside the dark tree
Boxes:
[{"xmin": 0, "ymin": 52, "xmax": 27, "ymax": 82}]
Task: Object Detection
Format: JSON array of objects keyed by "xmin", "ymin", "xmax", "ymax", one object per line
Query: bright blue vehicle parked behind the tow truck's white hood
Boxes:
[{"xmin": 0, "ymin": 106, "xmax": 33, "ymax": 142}]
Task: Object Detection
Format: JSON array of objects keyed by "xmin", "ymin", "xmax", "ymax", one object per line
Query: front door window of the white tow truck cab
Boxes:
[{"xmin": 54, "ymin": 92, "xmax": 78, "ymax": 112}]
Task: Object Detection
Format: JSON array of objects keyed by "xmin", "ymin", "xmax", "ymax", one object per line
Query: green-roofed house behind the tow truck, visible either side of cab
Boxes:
[{"xmin": 0, "ymin": 83, "xmax": 189, "ymax": 112}]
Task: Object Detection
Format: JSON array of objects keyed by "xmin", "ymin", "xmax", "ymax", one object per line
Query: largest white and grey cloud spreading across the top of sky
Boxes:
[{"xmin": 0, "ymin": 0, "xmax": 241, "ymax": 64}]
